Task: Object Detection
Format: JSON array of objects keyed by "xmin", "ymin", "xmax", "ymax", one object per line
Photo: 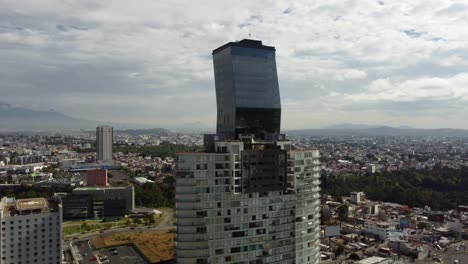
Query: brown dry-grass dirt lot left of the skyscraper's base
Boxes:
[{"xmin": 91, "ymin": 231, "xmax": 175, "ymax": 263}]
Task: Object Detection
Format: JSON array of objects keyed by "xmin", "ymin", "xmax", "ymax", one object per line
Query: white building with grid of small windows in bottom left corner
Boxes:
[{"xmin": 0, "ymin": 197, "xmax": 62, "ymax": 264}]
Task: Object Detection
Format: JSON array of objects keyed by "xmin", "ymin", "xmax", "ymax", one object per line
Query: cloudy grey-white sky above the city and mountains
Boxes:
[{"xmin": 0, "ymin": 0, "xmax": 468, "ymax": 129}]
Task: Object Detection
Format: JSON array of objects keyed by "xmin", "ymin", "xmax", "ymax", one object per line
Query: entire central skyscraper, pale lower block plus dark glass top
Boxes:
[{"xmin": 176, "ymin": 40, "xmax": 320, "ymax": 264}]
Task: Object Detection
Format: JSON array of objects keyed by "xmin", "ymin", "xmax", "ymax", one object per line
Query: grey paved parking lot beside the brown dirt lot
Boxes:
[{"xmin": 96, "ymin": 246, "xmax": 147, "ymax": 264}]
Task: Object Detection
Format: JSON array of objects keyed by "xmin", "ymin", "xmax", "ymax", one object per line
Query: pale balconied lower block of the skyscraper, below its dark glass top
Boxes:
[{"xmin": 176, "ymin": 141, "xmax": 320, "ymax": 264}]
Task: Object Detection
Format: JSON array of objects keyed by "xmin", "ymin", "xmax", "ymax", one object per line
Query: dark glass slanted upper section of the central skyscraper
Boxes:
[{"xmin": 213, "ymin": 39, "xmax": 281, "ymax": 139}]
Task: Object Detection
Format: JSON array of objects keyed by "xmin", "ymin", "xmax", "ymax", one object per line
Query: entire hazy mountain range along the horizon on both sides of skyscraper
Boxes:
[{"xmin": 0, "ymin": 102, "xmax": 468, "ymax": 137}]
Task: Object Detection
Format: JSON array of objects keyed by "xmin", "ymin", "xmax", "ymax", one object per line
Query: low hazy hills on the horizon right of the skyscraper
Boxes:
[{"xmin": 285, "ymin": 126, "xmax": 468, "ymax": 137}]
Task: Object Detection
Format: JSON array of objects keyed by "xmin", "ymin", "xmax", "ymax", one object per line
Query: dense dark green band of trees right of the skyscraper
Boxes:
[{"xmin": 320, "ymin": 167, "xmax": 468, "ymax": 210}]
